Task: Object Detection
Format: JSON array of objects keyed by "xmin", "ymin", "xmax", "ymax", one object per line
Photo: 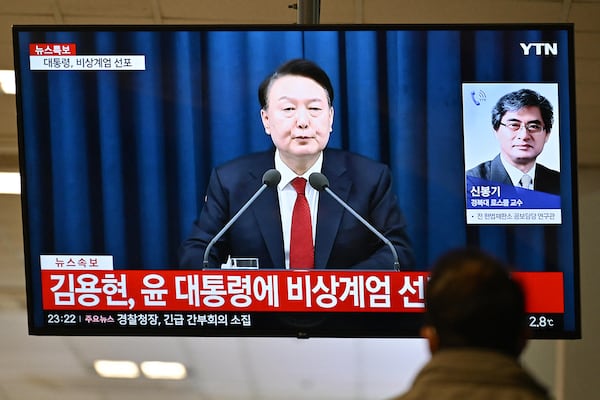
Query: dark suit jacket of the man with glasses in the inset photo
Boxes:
[{"xmin": 467, "ymin": 154, "xmax": 560, "ymax": 194}]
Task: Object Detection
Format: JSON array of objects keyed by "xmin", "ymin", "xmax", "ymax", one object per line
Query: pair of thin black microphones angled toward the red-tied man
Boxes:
[{"xmin": 202, "ymin": 169, "xmax": 400, "ymax": 271}]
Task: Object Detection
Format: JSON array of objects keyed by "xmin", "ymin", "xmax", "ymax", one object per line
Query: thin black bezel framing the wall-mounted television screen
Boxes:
[{"xmin": 12, "ymin": 23, "xmax": 581, "ymax": 339}]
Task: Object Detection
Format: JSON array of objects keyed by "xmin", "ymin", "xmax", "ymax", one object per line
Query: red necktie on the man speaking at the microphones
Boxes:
[{"xmin": 290, "ymin": 178, "xmax": 315, "ymax": 269}]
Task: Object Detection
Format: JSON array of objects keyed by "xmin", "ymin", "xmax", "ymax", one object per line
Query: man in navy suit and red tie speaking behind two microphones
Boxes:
[{"xmin": 179, "ymin": 59, "xmax": 413, "ymax": 269}]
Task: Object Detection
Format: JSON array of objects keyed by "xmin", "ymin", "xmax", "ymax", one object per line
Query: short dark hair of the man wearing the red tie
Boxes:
[{"xmin": 258, "ymin": 58, "xmax": 333, "ymax": 109}]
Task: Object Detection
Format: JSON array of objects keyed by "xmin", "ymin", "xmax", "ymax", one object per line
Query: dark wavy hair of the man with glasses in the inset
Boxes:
[{"xmin": 492, "ymin": 89, "xmax": 554, "ymax": 133}]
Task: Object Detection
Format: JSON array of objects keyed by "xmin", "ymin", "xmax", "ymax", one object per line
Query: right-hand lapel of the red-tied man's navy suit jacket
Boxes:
[{"xmin": 315, "ymin": 151, "xmax": 352, "ymax": 268}]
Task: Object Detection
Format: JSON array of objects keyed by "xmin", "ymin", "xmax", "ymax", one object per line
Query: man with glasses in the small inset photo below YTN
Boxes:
[{"xmin": 467, "ymin": 89, "xmax": 560, "ymax": 195}]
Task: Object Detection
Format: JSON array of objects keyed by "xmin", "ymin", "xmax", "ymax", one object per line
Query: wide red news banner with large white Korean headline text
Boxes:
[{"xmin": 41, "ymin": 270, "xmax": 564, "ymax": 314}]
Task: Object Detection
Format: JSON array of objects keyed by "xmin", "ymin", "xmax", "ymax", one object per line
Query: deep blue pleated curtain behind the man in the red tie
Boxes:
[{"xmin": 18, "ymin": 27, "xmax": 574, "ymax": 298}]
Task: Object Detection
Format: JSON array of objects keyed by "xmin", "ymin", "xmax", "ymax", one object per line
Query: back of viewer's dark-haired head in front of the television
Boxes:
[{"xmin": 425, "ymin": 249, "xmax": 526, "ymax": 356}]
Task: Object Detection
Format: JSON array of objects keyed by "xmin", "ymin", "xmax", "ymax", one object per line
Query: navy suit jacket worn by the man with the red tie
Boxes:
[{"xmin": 180, "ymin": 149, "xmax": 413, "ymax": 269}]
